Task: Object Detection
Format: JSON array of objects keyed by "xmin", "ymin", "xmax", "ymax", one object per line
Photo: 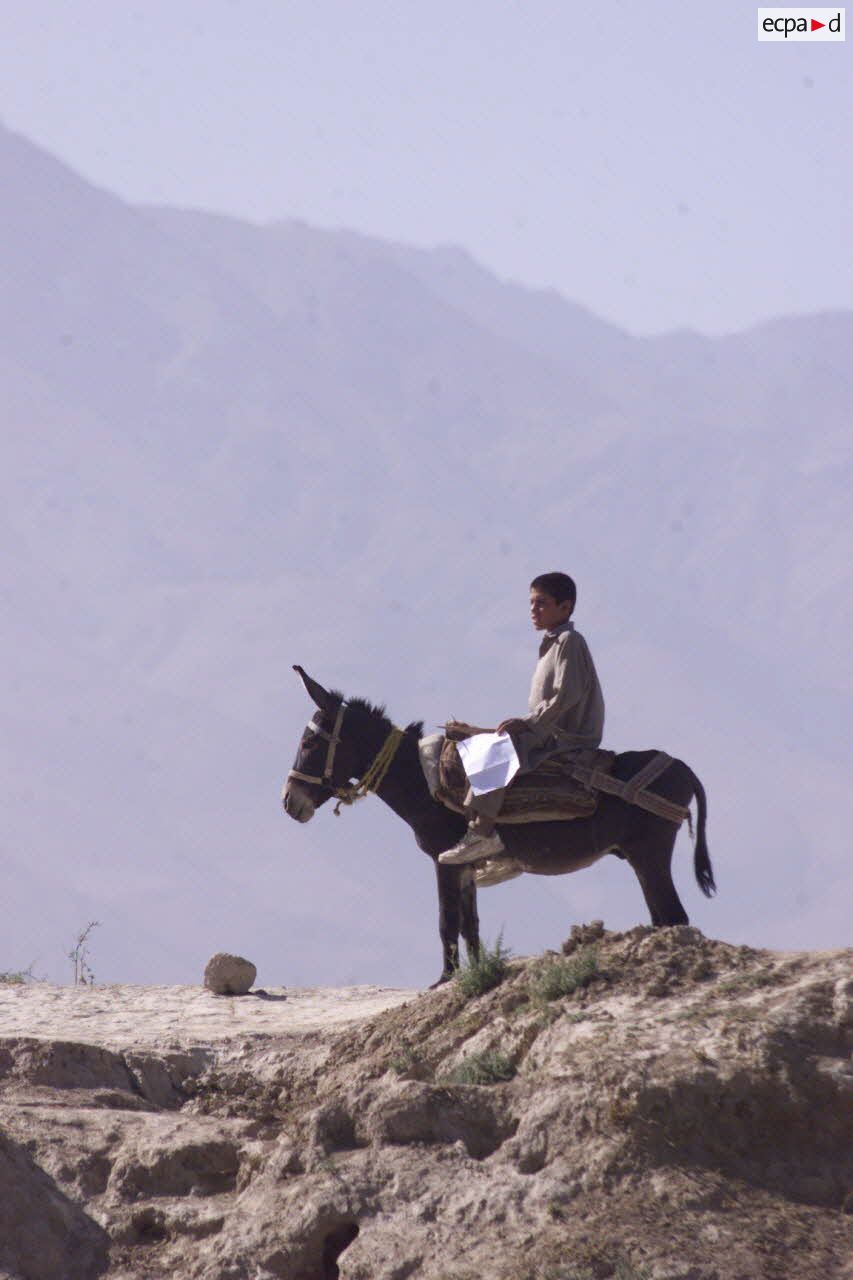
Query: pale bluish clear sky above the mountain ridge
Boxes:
[{"xmin": 0, "ymin": 0, "xmax": 853, "ymax": 333}]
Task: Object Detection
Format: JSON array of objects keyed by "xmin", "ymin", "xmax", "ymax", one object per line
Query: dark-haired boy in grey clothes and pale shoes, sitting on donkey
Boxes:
[{"xmin": 438, "ymin": 573, "xmax": 605, "ymax": 883}]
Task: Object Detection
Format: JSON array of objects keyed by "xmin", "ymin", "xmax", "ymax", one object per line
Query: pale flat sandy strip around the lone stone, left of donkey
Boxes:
[{"xmin": 0, "ymin": 983, "xmax": 420, "ymax": 1050}]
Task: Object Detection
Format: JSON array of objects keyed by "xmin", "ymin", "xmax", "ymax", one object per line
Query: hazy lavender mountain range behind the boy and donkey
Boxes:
[{"xmin": 0, "ymin": 129, "xmax": 853, "ymax": 983}]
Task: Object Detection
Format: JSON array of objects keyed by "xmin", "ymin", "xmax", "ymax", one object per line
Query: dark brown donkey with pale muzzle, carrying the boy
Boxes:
[{"xmin": 282, "ymin": 667, "xmax": 716, "ymax": 987}]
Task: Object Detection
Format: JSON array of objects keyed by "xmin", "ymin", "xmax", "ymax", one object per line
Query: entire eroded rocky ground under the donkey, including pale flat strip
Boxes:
[{"xmin": 0, "ymin": 925, "xmax": 853, "ymax": 1280}]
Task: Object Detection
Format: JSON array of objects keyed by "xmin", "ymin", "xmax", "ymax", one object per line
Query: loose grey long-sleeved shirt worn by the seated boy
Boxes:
[{"xmin": 519, "ymin": 622, "xmax": 605, "ymax": 765}]
